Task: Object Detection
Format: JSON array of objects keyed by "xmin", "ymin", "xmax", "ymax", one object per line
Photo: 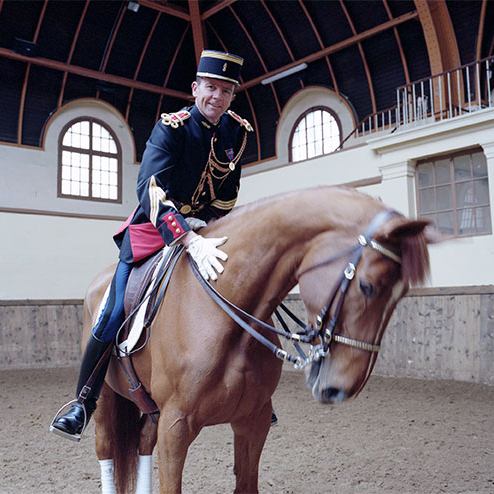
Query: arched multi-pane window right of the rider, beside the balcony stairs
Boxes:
[{"xmin": 289, "ymin": 106, "xmax": 341, "ymax": 161}]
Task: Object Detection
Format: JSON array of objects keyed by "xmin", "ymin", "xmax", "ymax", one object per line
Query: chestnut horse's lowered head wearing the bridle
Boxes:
[{"xmin": 299, "ymin": 210, "xmax": 429, "ymax": 403}]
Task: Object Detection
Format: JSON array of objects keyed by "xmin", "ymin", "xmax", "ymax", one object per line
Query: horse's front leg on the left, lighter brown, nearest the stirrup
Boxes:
[{"xmin": 158, "ymin": 409, "xmax": 200, "ymax": 494}]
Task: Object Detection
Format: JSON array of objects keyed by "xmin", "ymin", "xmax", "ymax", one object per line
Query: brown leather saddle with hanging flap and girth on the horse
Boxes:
[{"xmin": 116, "ymin": 246, "xmax": 184, "ymax": 414}]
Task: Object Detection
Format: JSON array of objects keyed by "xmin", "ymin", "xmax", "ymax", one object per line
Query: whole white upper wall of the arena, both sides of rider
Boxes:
[{"xmin": 0, "ymin": 94, "xmax": 494, "ymax": 300}]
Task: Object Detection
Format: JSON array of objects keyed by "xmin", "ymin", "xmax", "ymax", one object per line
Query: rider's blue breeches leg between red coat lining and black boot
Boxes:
[{"xmin": 93, "ymin": 261, "xmax": 132, "ymax": 342}]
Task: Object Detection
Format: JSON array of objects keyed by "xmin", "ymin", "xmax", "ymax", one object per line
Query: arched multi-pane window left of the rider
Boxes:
[{"xmin": 58, "ymin": 117, "xmax": 122, "ymax": 202}]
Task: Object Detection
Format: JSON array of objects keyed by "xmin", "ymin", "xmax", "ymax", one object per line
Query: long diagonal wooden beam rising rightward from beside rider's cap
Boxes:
[{"xmin": 239, "ymin": 10, "xmax": 418, "ymax": 91}]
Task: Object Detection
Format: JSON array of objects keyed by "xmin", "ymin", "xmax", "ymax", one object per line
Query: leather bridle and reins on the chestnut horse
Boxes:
[{"xmin": 189, "ymin": 210, "xmax": 401, "ymax": 369}]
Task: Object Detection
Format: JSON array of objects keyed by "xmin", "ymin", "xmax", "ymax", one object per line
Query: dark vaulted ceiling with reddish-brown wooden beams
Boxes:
[{"xmin": 0, "ymin": 0, "xmax": 494, "ymax": 163}]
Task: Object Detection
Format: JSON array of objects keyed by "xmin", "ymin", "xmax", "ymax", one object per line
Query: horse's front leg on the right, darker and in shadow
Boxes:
[{"xmin": 231, "ymin": 401, "xmax": 272, "ymax": 494}]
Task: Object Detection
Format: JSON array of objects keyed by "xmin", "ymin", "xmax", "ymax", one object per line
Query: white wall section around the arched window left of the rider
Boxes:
[{"xmin": 0, "ymin": 100, "xmax": 139, "ymax": 300}]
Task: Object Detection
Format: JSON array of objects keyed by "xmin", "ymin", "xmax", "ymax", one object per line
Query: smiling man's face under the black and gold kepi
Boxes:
[{"xmin": 192, "ymin": 77, "xmax": 235, "ymax": 124}]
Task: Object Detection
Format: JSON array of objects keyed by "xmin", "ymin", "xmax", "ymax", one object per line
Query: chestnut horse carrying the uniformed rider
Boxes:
[{"xmin": 83, "ymin": 187, "xmax": 429, "ymax": 494}]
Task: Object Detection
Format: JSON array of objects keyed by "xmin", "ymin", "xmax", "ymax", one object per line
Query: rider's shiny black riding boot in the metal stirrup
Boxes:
[{"xmin": 50, "ymin": 334, "xmax": 110, "ymax": 441}]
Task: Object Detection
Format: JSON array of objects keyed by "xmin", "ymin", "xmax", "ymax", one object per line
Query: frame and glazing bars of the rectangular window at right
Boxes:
[{"xmin": 415, "ymin": 147, "xmax": 493, "ymax": 238}]
